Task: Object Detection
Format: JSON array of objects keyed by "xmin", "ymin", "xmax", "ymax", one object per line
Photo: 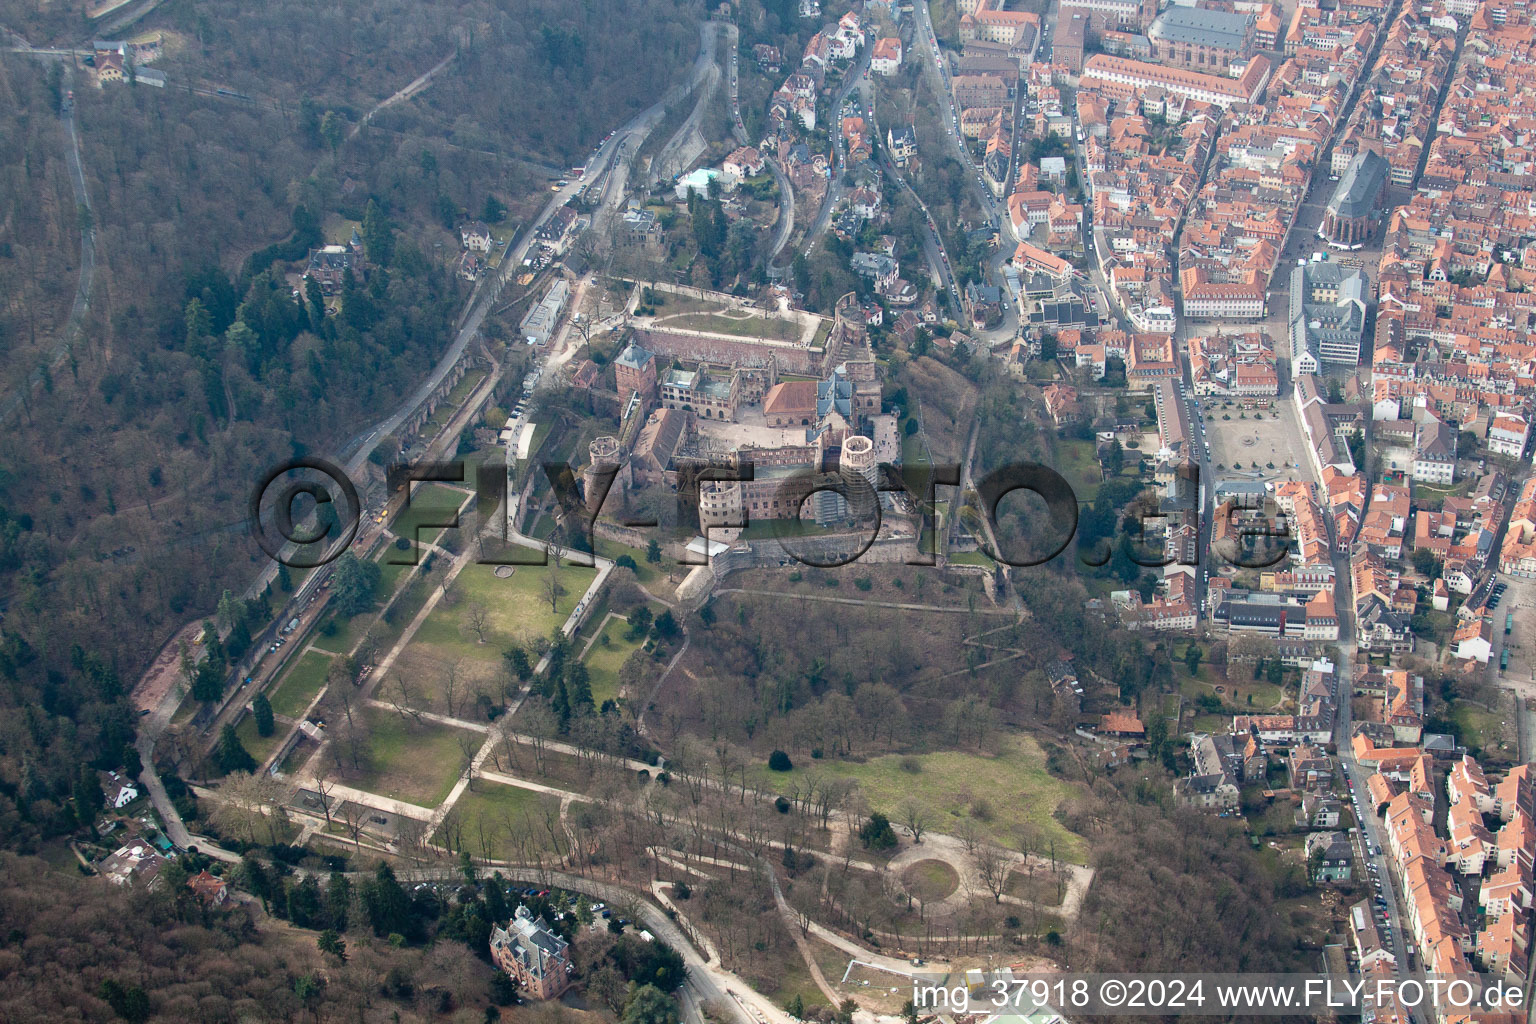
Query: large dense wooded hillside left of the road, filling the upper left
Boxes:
[{"xmin": 0, "ymin": 0, "xmax": 700, "ymax": 846}]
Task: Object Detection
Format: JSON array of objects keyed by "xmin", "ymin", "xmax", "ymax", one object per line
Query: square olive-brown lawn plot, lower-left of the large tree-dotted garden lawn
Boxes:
[{"xmin": 347, "ymin": 708, "xmax": 482, "ymax": 808}]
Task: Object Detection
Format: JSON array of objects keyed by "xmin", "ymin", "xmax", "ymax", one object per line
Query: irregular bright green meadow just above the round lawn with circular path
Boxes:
[{"xmin": 756, "ymin": 735, "xmax": 1087, "ymax": 864}]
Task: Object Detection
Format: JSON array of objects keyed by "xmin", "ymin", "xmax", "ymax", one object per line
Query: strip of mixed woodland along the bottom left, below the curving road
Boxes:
[{"xmin": 0, "ymin": 854, "xmax": 685, "ymax": 1024}]
